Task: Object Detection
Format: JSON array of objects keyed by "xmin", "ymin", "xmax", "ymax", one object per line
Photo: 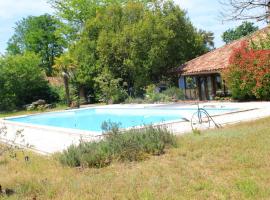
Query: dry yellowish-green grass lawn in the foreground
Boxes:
[{"xmin": 0, "ymin": 118, "xmax": 270, "ymax": 200}]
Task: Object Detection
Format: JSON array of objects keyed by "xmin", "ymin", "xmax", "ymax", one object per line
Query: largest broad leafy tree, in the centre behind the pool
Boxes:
[{"xmin": 66, "ymin": 1, "xmax": 208, "ymax": 96}]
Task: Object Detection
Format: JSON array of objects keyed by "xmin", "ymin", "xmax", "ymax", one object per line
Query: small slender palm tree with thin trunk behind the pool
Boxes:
[{"xmin": 53, "ymin": 53, "xmax": 76, "ymax": 106}]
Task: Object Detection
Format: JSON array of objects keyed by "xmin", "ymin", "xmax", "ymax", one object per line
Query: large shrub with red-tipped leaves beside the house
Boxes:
[{"xmin": 223, "ymin": 42, "xmax": 270, "ymax": 100}]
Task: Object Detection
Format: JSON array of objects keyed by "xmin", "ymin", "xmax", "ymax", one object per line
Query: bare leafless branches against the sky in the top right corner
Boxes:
[{"xmin": 220, "ymin": 0, "xmax": 270, "ymax": 21}]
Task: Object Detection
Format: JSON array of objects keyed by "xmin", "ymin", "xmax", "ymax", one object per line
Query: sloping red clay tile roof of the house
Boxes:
[{"xmin": 177, "ymin": 26, "xmax": 270, "ymax": 75}]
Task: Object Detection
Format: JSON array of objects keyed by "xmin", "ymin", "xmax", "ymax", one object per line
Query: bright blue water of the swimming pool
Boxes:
[{"xmin": 8, "ymin": 108, "xmax": 235, "ymax": 132}]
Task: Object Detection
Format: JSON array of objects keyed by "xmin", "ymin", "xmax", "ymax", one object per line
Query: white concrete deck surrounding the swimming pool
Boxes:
[{"xmin": 0, "ymin": 102, "xmax": 270, "ymax": 154}]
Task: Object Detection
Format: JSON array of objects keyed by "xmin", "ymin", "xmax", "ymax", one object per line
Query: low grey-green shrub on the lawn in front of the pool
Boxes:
[{"xmin": 60, "ymin": 122, "xmax": 176, "ymax": 168}]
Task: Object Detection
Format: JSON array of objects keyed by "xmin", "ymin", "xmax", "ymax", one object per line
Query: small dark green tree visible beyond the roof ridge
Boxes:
[{"xmin": 221, "ymin": 22, "xmax": 259, "ymax": 44}]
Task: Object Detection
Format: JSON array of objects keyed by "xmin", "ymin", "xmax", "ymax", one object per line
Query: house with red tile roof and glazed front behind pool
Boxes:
[{"xmin": 176, "ymin": 26, "xmax": 270, "ymax": 100}]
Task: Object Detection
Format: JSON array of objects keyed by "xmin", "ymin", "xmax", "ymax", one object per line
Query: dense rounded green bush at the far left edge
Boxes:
[{"xmin": 0, "ymin": 53, "xmax": 58, "ymax": 110}]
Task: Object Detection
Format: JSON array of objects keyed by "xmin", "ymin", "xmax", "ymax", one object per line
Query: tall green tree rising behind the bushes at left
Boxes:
[{"xmin": 7, "ymin": 14, "xmax": 67, "ymax": 76}]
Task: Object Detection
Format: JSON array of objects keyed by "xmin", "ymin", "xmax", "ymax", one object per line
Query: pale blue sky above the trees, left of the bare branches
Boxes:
[{"xmin": 0, "ymin": 0, "xmax": 265, "ymax": 54}]
